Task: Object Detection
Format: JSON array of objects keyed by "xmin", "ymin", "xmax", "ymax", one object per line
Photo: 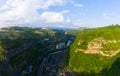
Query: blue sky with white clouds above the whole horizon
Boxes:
[{"xmin": 0, "ymin": 0, "xmax": 120, "ymax": 28}]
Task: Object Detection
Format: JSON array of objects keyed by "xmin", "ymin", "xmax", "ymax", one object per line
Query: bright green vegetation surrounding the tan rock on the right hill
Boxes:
[{"xmin": 69, "ymin": 26, "xmax": 120, "ymax": 76}]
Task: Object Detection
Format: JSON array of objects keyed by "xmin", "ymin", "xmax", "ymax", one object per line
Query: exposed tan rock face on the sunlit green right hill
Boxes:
[{"xmin": 75, "ymin": 38, "xmax": 120, "ymax": 57}]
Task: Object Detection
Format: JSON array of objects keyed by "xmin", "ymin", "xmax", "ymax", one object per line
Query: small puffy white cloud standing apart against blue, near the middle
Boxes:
[{"xmin": 41, "ymin": 12, "xmax": 64, "ymax": 23}]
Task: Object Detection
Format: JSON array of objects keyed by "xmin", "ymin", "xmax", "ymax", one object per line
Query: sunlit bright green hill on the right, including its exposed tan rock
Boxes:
[{"xmin": 69, "ymin": 25, "xmax": 120, "ymax": 76}]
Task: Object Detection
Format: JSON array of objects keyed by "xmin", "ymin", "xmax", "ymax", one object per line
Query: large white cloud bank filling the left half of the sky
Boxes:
[{"xmin": 0, "ymin": 0, "xmax": 67, "ymax": 27}]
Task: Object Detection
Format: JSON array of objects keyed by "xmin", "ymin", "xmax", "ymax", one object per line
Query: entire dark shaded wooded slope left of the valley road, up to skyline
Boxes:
[{"xmin": 0, "ymin": 27, "xmax": 66, "ymax": 76}]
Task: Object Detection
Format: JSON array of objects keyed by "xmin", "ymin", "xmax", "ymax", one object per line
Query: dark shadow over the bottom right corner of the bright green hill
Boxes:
[{"xmin": 67, "ymin": 58, "xmax": 120, "ymax": 76}]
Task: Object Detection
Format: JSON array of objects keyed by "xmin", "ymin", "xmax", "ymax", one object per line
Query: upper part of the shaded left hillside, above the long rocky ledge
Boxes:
[{"xmin": 0, "ymin": 27, "xmax": 56, "ymax": 61}]
